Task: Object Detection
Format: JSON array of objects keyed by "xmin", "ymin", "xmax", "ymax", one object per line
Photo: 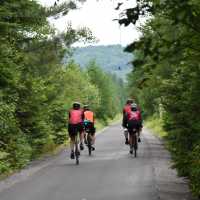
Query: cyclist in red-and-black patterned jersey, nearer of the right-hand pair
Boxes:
[{"xmin": 126, "ymin": 103, "xmax": 141, "ymax": 154}]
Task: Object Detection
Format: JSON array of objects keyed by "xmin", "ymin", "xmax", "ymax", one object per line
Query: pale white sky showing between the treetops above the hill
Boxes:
[{"xmin": 37, "ymin": 0, "xmax": 140, "ymax": 46}]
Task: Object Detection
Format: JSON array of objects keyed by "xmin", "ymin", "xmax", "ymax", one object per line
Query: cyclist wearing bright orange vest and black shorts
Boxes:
[{"xmin": 83, "ymin": 105, "xmax": 95, "ymax": 151}]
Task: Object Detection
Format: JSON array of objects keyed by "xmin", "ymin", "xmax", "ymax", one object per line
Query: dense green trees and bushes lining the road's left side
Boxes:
[{"xmin": 0, "ymin": 0, "xmax": 125, "ymax": 174}]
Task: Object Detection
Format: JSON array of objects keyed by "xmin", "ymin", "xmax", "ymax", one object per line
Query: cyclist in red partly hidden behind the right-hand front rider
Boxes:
[{"xmin": 122, "ymin": 99, "xmax": 133, "ymax": 145}]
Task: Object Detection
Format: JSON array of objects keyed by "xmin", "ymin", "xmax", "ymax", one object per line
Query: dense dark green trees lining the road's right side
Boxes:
[{"xmin": 120, "ymin": 0, "xmax": 200, "ymax": 197}]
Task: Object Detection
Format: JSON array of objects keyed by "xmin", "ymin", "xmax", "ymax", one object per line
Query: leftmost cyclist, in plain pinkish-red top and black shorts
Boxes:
[{"xmin": 68, "ymin": 102, "xmax": 84, "ymax": 159}]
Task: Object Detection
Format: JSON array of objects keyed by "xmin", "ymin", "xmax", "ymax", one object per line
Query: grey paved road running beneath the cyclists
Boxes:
[{"xmin": 0, "ymin": 125, "xmax": 194, "ymax": 200}]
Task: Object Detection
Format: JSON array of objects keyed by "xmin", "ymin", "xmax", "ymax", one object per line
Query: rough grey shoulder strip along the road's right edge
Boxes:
[{"xmin": 143, "ymin": 128, "xmax": 196, "ymax": 200}]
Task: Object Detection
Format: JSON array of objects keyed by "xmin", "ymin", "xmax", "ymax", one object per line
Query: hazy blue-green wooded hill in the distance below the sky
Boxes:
[{"xmin": 69, "ymin": 45, "xmax": 133, "ymax": 79}]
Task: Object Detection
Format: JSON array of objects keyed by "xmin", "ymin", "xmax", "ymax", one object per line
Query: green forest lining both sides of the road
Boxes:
[{"xmin": 0, "ymin": 0, "xmax": 200, "ymax": 197}]
